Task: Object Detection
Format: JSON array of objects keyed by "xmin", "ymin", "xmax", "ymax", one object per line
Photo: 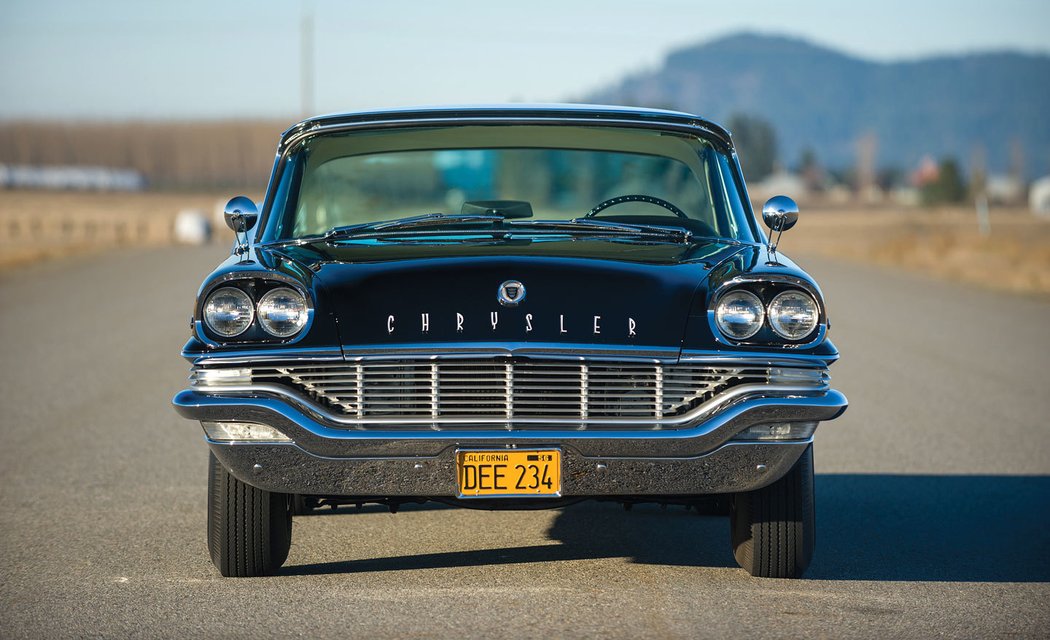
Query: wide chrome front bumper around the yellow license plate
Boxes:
[{"xmin": 172, "ymin": 389, "xmax": 847, "ymax": 497}]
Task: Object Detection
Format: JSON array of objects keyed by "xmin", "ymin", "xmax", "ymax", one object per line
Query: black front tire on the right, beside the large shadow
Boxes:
[{"xmin": 730, "ymin": 445, "xmax": 816, "ymax": 578}]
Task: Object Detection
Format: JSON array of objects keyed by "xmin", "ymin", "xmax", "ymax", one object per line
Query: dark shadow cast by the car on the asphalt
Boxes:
[{"xmin": 282, "ymin": 474, "xmax": 1050, "ymax": 582}]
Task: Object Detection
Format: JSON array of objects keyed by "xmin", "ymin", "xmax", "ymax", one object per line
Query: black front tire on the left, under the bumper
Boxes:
[{"xmin": 208, "ymin": 453, "xmax": 292, "ymax": 577}]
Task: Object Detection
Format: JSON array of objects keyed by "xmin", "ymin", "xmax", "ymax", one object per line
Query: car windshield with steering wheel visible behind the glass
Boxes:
[{"xmin": 266, "ymin": 125, "xmax": 752, "ymax": 241}]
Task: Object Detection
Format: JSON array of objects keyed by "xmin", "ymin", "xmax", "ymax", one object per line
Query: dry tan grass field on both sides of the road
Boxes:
[{"xmin": 0, "ymin": 191, "xmax": 1050, "ymax": 296}]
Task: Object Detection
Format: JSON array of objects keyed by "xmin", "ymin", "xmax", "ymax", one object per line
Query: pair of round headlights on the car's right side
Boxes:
[{"xmin": 714, "ymin": 289, "xmax": 820, "ymax": 342}]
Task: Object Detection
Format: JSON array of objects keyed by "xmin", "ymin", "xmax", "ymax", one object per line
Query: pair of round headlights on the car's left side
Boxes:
[{"xmin": 201, "ymin": 285, "xmax": 310, "ymax": 339}]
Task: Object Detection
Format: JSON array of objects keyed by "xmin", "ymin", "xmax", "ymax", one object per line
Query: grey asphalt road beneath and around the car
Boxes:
[{"xmin": 0, "ymin": 240, "xmax": 1050, "ymax": 638}]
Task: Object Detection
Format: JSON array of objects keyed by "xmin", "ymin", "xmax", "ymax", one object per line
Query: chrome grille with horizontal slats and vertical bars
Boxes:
[{"xmin": 193, "ymin": 358, "xmax": 793, "ymax": 425}]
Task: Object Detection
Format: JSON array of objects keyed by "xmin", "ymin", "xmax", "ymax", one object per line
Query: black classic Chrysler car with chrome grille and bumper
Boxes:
[{"xmin": 173, "ymin": 105, "xmax": 846, "ymax": 577}]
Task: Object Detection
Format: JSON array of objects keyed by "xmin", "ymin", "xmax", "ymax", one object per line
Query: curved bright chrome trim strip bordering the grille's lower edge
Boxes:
[{"xmin": 190, "ymin": 380, "xmax": 830, "ymax": 425}]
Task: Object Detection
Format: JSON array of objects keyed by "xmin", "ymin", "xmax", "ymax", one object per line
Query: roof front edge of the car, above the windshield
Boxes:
[{"xmin": 281, "ymin": 104, "xmax": 733, "ymax": 147}]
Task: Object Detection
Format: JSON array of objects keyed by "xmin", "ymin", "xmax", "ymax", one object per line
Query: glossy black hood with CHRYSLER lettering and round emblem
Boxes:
[{"xmin": 274, "ymin": 237, "xmax": 741, "ymax": 350}]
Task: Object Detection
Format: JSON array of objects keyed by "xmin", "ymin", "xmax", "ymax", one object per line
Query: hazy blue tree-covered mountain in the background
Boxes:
[{"xmin": 586, "ymin": 34, "xmax": 1050, "ymax": 177}]
